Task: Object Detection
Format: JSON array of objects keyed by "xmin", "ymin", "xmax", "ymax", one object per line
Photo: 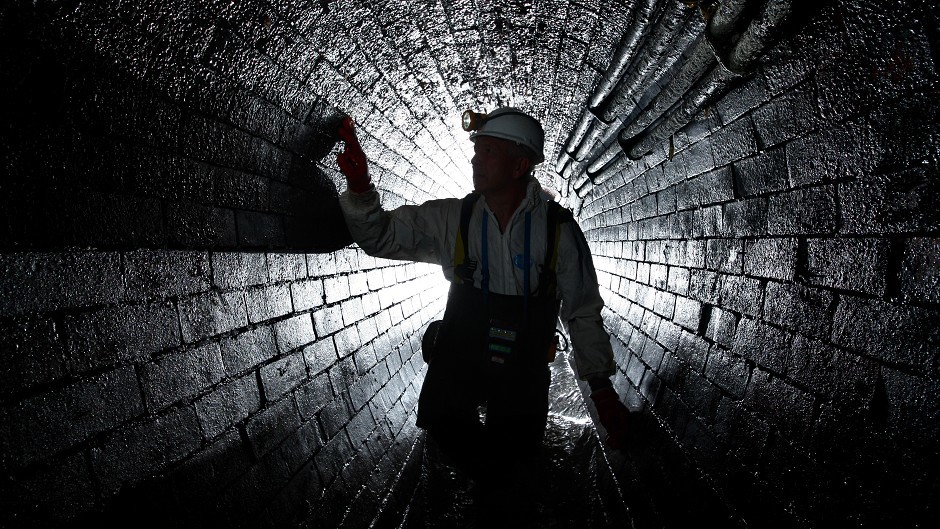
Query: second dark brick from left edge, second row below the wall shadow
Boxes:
[{"xmin": 65, "ymin": 303, "xmax": 180, "ymax": 373}]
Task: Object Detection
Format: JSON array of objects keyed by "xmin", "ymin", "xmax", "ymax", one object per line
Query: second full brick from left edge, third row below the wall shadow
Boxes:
[{"xmin": 140, "ymin": 343, "xmax": 225, "ymax": 411}]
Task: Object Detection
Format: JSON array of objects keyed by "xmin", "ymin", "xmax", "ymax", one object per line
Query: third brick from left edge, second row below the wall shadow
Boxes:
[{"xmin": 179, "ymin": 291, "xmax": 248, "ymax": 343}]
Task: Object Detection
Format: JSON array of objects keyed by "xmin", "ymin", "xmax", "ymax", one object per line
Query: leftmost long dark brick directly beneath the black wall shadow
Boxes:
[{"xmin": 0, "ymin": 252, "xmax": 123, "ymax": 316}]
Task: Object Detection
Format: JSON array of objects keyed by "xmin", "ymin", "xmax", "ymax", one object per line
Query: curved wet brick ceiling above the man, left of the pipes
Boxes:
[{"xmin": 47, "ymin": 1, "xmax": 648, "ymax": 200}]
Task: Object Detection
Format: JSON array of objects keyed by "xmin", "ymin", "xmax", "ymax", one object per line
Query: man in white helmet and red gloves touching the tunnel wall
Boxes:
[{"xmin": 337, "ymin": 107, "xmax": 627, "ymax": 521}]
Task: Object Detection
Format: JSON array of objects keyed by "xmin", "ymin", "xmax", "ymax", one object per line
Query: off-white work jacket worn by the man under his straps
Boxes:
[{"xmin": 339, "ymin": 178, "xmax": 614, "ymax": 380}]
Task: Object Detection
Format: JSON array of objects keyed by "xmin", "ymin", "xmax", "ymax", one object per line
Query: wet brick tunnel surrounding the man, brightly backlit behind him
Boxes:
[{"xmin": 0, "ymin": 0, "xmax": 940, "ymax": 529}]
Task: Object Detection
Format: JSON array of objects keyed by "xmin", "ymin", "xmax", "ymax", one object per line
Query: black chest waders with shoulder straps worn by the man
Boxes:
[{"xmin": 417, "ymin": 193, "xmax": 571, "ymax": 427}]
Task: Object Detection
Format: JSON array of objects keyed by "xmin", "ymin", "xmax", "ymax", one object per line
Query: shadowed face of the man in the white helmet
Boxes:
[{"xmin": 470, "ymin": 136, "xmax": 526, "ymax": 195}]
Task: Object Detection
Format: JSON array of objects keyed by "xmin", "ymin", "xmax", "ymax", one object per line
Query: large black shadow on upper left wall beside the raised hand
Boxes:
[{"xmin": 0, "ymin": 6, "xmax": 352, "ymax": 253}]
